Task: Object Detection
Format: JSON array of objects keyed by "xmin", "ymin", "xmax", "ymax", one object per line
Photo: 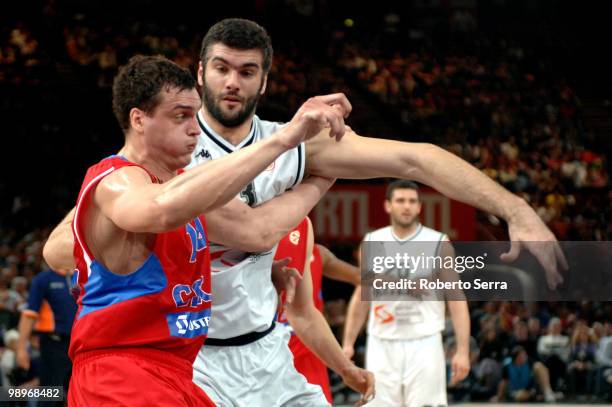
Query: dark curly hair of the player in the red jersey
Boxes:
[{"xmin": 113, "ymin": 55, "xmax": 196, "ymax": 132}]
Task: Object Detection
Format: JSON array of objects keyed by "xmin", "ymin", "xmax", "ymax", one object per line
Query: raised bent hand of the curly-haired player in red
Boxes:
[{"xmin": 280, "ymin": 93, "xmax": 352, "ymax": 148}]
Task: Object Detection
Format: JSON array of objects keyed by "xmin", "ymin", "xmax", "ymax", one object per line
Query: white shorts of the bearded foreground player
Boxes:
[{"xmin": 193, "ymin": 325, "xmax": 329, "ymax": 407}]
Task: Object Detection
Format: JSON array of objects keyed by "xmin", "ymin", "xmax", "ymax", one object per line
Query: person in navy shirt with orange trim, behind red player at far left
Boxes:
[{"xmin": 17, "ymin": 270, "xmax": 77, "ymax": 394}]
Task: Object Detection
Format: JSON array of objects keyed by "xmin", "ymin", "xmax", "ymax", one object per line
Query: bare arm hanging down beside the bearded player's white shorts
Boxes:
[{"xmin": 286, "ymin": 222, "xmax": 374, "ymax": 401}]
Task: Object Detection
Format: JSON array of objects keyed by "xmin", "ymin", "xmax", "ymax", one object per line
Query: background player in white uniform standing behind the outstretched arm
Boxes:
[{"xmin": 343, "ymin": 180, "xmax": 470, "ymax": 407}]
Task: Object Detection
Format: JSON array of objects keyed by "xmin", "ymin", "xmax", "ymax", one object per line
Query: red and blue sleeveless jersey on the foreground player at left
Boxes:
[{"xmin": 69, "ymin": 156, "xmax": 212, "ymax": 364}]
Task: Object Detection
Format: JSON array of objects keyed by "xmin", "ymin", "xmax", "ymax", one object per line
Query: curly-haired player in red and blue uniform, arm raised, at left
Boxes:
[{"xmin": 68, "ymin": 56, "xmax": 345, "ymax": 406}]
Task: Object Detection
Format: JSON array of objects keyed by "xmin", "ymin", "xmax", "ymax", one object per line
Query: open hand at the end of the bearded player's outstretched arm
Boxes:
[{"xmin": 501, "ymin": 204, "xmax": 568, "ymax": 289}]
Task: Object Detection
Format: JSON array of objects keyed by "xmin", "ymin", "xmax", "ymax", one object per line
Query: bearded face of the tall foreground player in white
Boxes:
[{"xmin": 198, "ymin": 44, "xmax": 267, "ymax": 127}]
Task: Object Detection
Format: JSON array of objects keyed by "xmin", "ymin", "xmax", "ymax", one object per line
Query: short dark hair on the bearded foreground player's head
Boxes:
[{"xmin": 200, "ymin": 18, "xmax": 273, "ymax": 74}]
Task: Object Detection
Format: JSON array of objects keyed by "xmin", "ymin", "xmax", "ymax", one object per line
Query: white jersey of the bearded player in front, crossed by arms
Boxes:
[{"xmin": 189, "ymin": 112, "xmax": 306, "ymax": 339}]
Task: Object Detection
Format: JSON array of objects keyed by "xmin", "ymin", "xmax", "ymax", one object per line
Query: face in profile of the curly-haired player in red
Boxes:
[{"xmin": 144, "ymin": 88, "xmax": 201, "ymax": 169}]
